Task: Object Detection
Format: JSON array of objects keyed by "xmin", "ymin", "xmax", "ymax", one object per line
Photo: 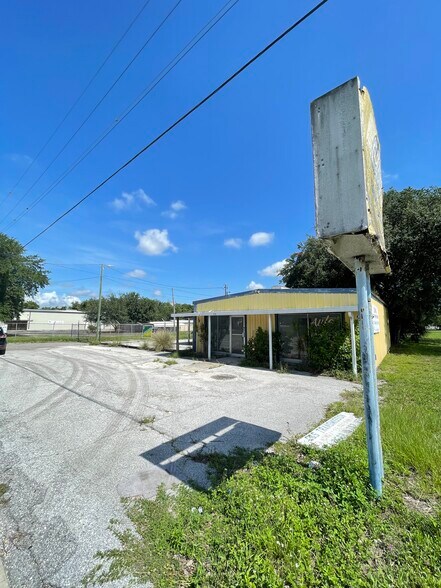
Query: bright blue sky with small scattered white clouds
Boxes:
[{"xmin": 0, "ymin": 0, "xmax": 441, "ymax": 305}]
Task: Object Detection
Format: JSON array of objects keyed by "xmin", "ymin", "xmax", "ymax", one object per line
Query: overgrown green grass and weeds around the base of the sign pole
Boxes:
[{"xmin": 85, "ymin": 333, "xmax": 441, "ymax": 588}]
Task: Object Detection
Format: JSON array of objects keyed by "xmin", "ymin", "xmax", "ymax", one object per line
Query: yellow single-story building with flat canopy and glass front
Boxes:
[{"xmin": 173, "ymin": 288, "xmax": 390, "ymax": 368}]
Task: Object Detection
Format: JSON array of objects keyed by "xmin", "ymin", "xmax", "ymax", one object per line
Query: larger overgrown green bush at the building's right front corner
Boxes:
[{"xmin": 308, "ymin": 321, "xmax": 360, "ymax": 372}]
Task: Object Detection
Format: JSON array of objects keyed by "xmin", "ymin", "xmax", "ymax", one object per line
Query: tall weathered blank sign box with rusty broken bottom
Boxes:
[{"xmin": 311, "ymin": 77, "xmax": 390, "ymax": 274}]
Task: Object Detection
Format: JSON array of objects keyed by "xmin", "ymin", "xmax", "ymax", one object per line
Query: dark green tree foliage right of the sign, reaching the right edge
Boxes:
[{"xmin": 373, "ymin": 188, "xmax": 441, "ymax": 342}]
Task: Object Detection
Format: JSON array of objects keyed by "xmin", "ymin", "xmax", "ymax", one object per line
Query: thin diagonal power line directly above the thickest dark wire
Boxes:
[{"xmin": 4, "ymin": 0, "xmax": 239, "ymax": 230}]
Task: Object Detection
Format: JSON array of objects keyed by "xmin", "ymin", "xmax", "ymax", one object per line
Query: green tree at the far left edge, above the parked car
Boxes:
[{"xmin": 0, "ymin": 233, "xmax": 49, "ymax": 321}]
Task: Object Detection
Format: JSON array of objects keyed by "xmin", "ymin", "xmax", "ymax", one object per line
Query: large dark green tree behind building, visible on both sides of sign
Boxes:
[{"xmin": 280, "ymin": 188, "xmax": 441, "ymax": 343}]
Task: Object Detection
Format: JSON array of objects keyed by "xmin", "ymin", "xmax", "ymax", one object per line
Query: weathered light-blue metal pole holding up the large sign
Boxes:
[{"xmin": 354, "ymin": 258, "xmax": 383, "ymax": 496}]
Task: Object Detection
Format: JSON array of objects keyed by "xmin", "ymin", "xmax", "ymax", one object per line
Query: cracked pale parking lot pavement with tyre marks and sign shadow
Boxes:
[{"xmin": 0, "ymin": 344, "xmax": 351, "ymax": 588}]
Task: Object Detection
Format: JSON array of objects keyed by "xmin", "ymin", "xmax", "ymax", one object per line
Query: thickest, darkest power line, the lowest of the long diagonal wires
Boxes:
[{"xmin": 24, "ymin": 0, "xmax": 328, "ymax": 247}]
